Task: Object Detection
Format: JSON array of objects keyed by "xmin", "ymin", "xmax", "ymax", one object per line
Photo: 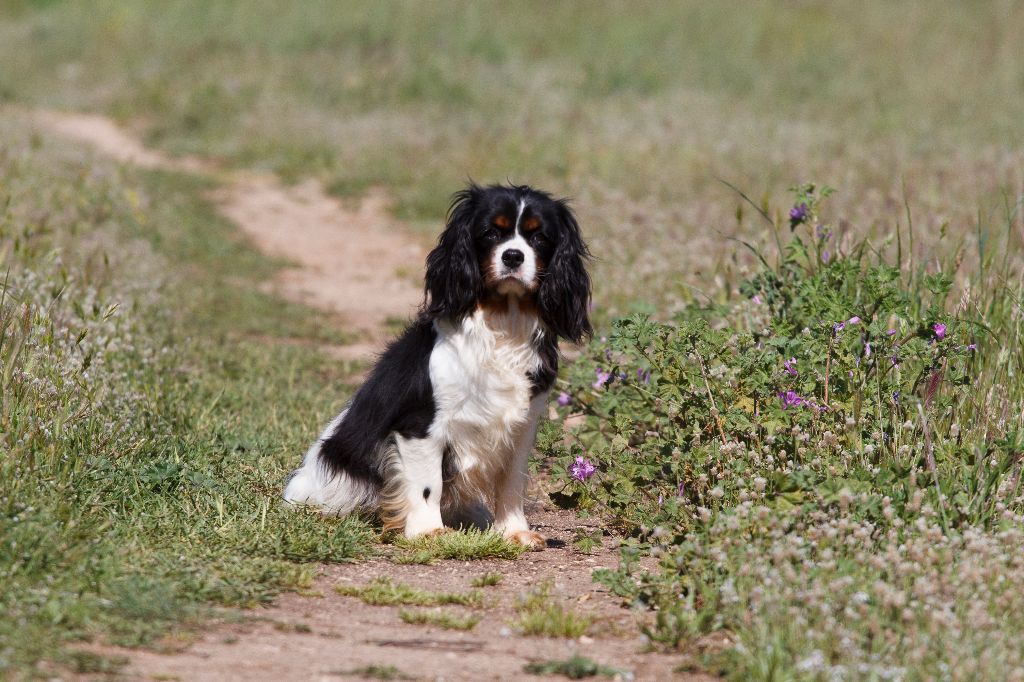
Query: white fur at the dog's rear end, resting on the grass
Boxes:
[{"xmin": 284, "ymin": 411, "xmax": 379, "ymax": 516}]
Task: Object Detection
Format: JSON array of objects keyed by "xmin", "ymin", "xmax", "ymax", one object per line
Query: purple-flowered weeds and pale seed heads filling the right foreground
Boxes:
[{"xmin": 542, "ymin": 184, "xmax": 1024, "ymax": 679}]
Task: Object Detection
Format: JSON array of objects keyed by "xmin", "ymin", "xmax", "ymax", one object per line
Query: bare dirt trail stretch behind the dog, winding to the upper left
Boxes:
[{"xmin": 34, "ymin": 112, "xmax": 426, "ymax": 358}]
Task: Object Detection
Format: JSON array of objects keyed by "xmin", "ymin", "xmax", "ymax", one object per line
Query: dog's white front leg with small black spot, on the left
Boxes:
[{"xmin": 382, "ymin": 435, "xmax": 444, "ymax": 538}]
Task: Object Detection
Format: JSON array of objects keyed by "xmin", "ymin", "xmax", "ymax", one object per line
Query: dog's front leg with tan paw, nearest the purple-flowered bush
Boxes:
[{"xmin": 494, "ymin": 393, "xmax": 548, "ymax": 549}]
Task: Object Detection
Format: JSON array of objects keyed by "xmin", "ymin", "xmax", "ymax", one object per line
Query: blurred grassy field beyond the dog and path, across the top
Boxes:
[{"xmin": 0, "ymin": 0, "xmax": 1024, "ymax": 313}]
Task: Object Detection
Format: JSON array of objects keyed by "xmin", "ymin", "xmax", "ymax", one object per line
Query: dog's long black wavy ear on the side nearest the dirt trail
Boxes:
[{"xmin": 423, "ymin": 184, "xmax": 483, "ymax": 321}]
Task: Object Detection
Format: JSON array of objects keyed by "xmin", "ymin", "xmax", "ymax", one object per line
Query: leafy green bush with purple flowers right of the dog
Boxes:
[{"xmin": 546, "ymin": 184, "xmax": 1003, "ymax": 538}]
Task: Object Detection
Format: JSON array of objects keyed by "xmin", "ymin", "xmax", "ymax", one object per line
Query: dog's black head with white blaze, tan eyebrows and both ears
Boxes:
[{"xmin": 425, "ymin": 184, "xmax": 591, "ymax": 342}]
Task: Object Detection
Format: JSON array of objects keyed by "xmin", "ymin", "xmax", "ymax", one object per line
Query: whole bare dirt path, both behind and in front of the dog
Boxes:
[{"xmin": 36, "ymin": 112, "xmax": 712, "ymax": 680}]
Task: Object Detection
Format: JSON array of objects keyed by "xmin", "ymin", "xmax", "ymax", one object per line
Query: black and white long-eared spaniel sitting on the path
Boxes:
[{"xmin": 285, "ymin": 184, "xmax": 591, "ymax": 547}]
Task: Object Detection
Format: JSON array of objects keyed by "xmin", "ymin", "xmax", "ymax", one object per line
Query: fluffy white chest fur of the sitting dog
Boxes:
[{"xmin": 430, "ymin": 299, "xmax": 541, "ymax": 471}]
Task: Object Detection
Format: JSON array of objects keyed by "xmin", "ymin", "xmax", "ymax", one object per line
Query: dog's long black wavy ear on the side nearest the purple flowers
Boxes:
[{"xmin": 538, "ymin": 201, "xmax": 593, "ymax": 343}]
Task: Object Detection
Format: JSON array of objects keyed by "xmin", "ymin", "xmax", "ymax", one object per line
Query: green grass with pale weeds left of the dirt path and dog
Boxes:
[{"xmin": 0, "ymin": 109, "xmax": 373, "ymax": 674}]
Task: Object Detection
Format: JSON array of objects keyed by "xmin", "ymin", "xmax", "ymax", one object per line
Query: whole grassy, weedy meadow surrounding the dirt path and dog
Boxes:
[{"xmin": 0, "ymin": 0, "xmax": 1024, "ymax": 679}]
